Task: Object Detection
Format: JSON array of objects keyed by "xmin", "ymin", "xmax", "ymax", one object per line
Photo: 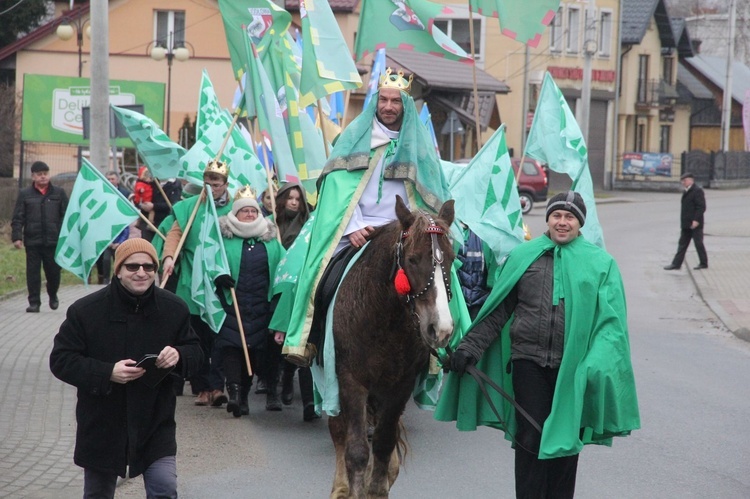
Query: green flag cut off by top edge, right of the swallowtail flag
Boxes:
[{"xmin": 469, "ymin": 0, "xmax": 560, "ymax": 47}]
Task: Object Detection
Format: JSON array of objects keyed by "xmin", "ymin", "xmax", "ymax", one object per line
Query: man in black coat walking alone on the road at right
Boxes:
[{"xmin": 664, "ymin": 173, "xmax": 708, "ymax": 270}]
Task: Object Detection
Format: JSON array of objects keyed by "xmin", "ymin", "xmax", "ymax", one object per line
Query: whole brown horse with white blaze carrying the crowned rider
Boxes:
[{"xmin": 328, "ymin": 197, "xmax": 460, "ymax": 498}]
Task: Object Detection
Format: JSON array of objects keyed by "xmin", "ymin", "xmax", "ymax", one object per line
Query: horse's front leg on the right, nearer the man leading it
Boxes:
[{"xmin": 367, "ymin": 393, "xmax": 409, "ymax": 497}]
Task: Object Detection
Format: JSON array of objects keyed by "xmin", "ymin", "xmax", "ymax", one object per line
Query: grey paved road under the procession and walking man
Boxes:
[{"xmin": 0, "ymin": 191, "xmax": 750, "ymax": 498}]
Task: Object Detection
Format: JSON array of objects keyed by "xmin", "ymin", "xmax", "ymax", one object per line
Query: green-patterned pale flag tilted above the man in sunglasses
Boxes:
[{"xmin": 55, "ymin": 158, "xmax": 138, "ymax": 283}]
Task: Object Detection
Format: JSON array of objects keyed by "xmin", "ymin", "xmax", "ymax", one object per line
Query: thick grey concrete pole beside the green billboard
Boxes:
[{"xmin": 89, "ymin": 0, "xmax": 110, "ymax": 171}]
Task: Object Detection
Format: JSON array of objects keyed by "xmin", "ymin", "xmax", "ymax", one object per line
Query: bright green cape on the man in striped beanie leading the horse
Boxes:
[{"xmin": 435, "ymin": 235, "xmax": 640, "ymax": 459}]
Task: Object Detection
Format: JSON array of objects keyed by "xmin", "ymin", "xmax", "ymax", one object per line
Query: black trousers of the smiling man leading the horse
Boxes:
[{"xmin": 513, "ymin": 360, "xmax": 578, "ymax": 499}]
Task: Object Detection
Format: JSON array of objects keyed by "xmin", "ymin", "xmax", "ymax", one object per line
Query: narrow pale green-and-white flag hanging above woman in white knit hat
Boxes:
[{"xmin": 245, "ymin": 39, "xmax": 299, "ymax": 182}]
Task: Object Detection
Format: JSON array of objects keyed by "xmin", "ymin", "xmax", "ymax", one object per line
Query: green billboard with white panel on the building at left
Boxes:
[{"xmin": 21, "ymin": 74, "xmax": 165, "ymax": 147}]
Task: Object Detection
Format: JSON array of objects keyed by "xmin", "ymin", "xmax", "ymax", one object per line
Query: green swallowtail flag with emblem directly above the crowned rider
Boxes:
[{"xmin": 354, "ymin": 0, "xmax": 473, "ymax": 64}]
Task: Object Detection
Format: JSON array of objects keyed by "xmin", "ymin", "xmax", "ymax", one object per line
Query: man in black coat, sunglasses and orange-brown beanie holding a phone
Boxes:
[{"xmin": 50, "ymin": 238, "xmax": 203, "ymax": 498}]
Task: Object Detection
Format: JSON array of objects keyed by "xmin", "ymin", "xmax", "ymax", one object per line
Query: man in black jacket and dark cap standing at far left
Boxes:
[{"xmin": 11, "ymin": 161, "xmax": 68, "ymax": 312}]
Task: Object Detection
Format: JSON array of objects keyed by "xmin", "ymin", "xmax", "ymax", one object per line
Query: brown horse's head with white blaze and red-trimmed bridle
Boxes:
[{"xmin": 396, "ymin": 197, "xmax": 461, "ymax": 349}]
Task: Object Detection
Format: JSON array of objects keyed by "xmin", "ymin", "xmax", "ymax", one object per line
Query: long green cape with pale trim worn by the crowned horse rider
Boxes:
[{"xmin": 271, "ymin": 92, "xmax": 450, "ymax": 355}]
